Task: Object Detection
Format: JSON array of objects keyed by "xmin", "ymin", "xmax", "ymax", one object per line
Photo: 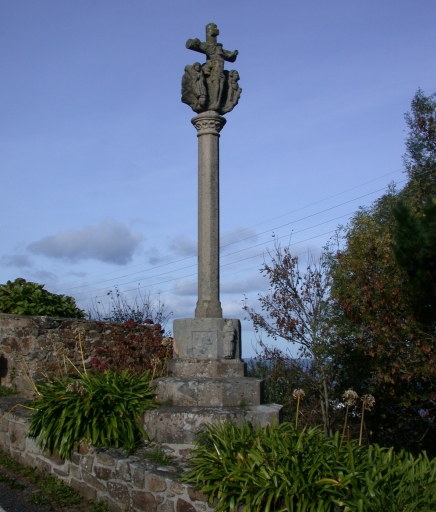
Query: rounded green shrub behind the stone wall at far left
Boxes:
[{"xmin": 0, "ymin": 278, "xmax": 85, "ymax": 318}]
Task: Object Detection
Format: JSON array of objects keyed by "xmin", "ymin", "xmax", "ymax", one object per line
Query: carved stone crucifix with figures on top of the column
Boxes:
[{"xmin": 182, "ymin": 23, "xmax": 242, "ymax": 114}]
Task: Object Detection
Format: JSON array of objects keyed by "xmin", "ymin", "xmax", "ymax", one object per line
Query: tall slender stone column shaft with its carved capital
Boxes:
[{"xmin": 192, "ymin": 111, "xmax": 226, "ymax": 318}]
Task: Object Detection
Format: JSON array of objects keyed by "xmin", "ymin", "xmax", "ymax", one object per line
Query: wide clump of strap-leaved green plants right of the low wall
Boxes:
[{"xmin": 183, "ymin": 423, "xmax": 436, "ymax": 512}]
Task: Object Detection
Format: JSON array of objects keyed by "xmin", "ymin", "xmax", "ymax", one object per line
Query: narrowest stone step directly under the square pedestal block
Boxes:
[{"xmin": 168, "ymin": 358, "xmax": 247, "ymax": 378}]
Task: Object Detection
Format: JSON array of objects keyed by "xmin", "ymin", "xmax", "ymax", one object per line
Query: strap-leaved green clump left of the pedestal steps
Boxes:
[{"xmin": 29, "ymin": 370, "xmax": 156, "ymax": 459}]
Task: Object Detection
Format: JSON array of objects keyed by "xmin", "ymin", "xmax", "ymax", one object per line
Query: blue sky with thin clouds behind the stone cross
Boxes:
[{"xmin": 0, "ymin": 0, "xmax": 436, "ymax": 356}]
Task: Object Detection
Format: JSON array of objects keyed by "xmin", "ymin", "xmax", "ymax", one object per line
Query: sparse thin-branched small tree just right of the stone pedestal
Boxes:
[{"xmin": 244, "ymin": 244, "xmax": 332, "ymax": 434}]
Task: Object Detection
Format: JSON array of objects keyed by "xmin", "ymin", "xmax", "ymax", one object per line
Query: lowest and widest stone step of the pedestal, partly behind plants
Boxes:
[{"xmin": 143, "ymin": 404, "xmax": 283, "ymax": 444}]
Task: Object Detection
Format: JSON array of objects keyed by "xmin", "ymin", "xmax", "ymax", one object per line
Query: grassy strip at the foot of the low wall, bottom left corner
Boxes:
[{"xmin": 0, "ymin": 450, "xmax": 109, "ymax": 512}]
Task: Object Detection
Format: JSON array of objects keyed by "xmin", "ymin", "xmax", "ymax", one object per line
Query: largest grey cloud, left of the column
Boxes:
[{"xmin": 27, "ymin": 219, "xmax": 143, "ymax": 265}]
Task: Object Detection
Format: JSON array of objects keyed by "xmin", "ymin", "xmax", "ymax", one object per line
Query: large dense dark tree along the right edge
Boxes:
[{"xmin": 331, "ymin": 90, "xmax": 436, "ymax": 454}]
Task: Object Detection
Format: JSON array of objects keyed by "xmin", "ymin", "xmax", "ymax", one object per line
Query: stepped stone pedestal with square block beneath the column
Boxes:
[{"xmin": 144, "ymin": 318, "xmax": 282, "ymax": 444}]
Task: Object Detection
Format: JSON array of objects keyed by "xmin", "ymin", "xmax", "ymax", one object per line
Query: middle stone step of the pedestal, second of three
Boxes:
[{"xmin": 153, "ymin": 377, "xmax": 263, "ymax": 407}]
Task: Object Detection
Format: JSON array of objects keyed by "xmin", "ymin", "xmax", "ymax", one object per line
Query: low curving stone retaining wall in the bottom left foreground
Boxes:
[{"xmin": 0, "ymin": 395, "xmax": 213, "ymax": 512}]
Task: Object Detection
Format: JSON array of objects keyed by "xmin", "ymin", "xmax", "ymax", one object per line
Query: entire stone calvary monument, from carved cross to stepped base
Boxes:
[{"xmin": 144, "ymin": 23, "xmax": 282, "ymax": 444}]
